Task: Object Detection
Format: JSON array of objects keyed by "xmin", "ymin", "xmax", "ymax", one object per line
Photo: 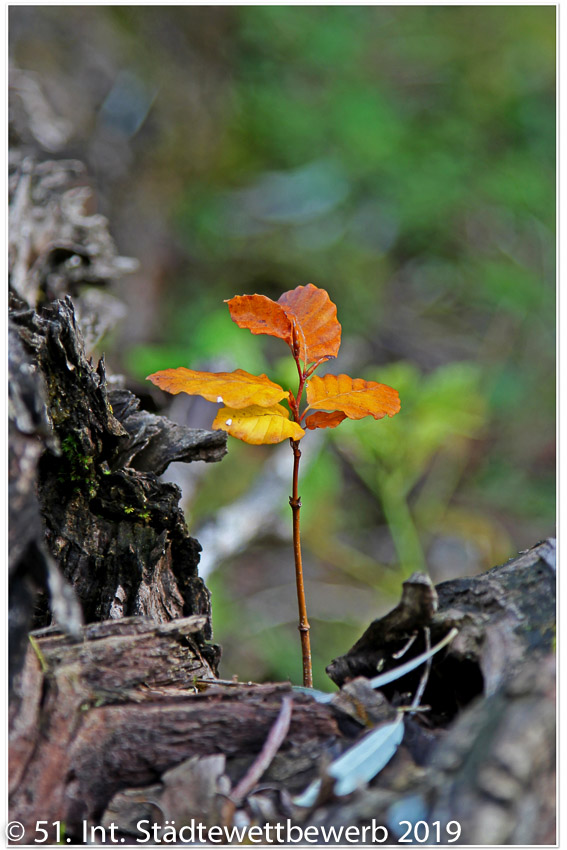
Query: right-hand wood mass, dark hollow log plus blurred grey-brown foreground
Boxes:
[{"xmin": 309, "ymin": 540, "xmax": 556, "ymax": 846}]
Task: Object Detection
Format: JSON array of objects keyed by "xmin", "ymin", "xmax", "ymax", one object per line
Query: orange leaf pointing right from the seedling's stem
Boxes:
[{"xmin": 307, "ymin": 375, "xmax": 400, "ymax": 419}]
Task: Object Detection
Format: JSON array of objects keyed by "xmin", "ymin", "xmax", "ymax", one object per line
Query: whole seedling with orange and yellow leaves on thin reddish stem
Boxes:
[{"xmin": 148, "ymin": 283, "xmax": 400, "ymax": 687}]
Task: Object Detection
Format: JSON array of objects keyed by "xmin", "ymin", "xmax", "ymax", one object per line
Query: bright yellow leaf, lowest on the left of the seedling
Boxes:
[{"xmin": 212, "ymin": 404, "xmax": 305, "ymax": 446}]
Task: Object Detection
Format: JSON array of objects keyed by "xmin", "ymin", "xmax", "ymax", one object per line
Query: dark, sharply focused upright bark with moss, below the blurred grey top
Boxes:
[{"xmin": 11, "ymin": 288, "xmax": 226, "ymax": 636}]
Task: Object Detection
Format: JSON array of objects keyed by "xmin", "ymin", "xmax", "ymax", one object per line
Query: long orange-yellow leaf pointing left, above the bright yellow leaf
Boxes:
[{"xmin": 146, "ymin": 366, "xmax": 287, "ymax": 409}]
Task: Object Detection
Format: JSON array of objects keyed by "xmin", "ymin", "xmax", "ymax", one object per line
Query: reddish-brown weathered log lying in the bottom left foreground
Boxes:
[{"xmin": 10, "ymin": 616, "xmax": 337, "ymax": 836}]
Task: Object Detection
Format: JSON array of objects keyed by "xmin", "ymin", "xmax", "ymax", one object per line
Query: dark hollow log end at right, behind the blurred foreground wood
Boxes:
[{"xmin": 327, "ymin": 541, "xmax": 556, "ymax": 725}]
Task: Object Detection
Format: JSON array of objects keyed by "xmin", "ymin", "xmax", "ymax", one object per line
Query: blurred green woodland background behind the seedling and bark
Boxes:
[{"xmin": 10, "ymin": 6, "xmax": 556, "ymax": 687}]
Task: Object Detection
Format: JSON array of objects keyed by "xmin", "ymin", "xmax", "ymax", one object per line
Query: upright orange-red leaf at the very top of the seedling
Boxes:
[{"xmin": 278, "ymin": 283, "xmax": 341, "ymax": 364}]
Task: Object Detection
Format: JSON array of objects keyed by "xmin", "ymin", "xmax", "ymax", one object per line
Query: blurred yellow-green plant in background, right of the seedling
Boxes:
[{"xmin": 336, "ymin": 363, "xmax": 486, "ymax": 578}]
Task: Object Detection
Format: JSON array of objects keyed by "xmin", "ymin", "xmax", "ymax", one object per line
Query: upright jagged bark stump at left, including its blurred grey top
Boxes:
[{"xmin": 9, "ymin": 155, "xmax": 226, "ymax": 696}]
